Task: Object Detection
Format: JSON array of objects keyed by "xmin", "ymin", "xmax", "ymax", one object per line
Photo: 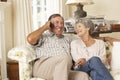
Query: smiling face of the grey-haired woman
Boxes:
[{"xmin": 75, "ymin": 22, "xmax": 89, "ymax": 37}]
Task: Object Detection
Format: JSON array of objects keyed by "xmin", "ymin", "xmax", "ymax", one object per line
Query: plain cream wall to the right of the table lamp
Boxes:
[{"xmin": 85, "ymin": 0, "xmax": 120, "ymax": 20}]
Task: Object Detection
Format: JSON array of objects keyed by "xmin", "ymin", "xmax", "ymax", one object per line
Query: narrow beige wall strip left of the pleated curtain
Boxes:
[{"xmin": 5, "ymin": 3, "xmax": 13, "ymax": 54}]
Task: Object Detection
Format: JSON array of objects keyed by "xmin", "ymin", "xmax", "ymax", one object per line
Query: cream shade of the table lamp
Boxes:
[{"xmin": 66, "ymin": 0, "xmax": 93, "ymax": 5}]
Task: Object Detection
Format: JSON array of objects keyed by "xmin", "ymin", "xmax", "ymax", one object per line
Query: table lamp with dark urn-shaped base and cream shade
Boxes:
[{"xmin": 66, "ymin": 0, "xmax": 93, "ymax": 19}]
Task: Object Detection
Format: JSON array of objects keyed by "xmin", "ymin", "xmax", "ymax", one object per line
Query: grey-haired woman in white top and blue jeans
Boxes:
[{"xmin": 71, "ymin": 18, "xmax": 113, "ymax": 80}]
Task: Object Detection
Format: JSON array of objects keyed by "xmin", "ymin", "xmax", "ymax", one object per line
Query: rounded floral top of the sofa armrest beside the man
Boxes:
[{"xmin": 8, "ymin": 45, "xmax": 36, "ymax": 63}]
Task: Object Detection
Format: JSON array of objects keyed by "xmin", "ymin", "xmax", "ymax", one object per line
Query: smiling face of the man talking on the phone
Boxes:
[{"xmin": 51, "ymin": 16, "xmax": 64, "ymax": 37}]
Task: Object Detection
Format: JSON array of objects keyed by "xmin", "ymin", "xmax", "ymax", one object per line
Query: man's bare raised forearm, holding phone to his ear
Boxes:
[{"xmin": 27, "ymin": 21, "xmax": 50, "ymax": 45}]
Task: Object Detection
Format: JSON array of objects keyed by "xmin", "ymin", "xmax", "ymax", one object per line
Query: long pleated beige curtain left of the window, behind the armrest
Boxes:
[{"xmin": 12, "ymin": 0, "xmax": 33, "ymax": 46}]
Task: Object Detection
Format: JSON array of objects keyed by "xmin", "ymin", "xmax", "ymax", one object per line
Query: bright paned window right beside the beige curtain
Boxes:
[{"xmin": 32, "ymin": 0, "xmax": 47, "ymax": 29}]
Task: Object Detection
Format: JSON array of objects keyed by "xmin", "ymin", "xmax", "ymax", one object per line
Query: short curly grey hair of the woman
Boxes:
[{"xmin": 75, "ymin": 18, "xmax": 95, "ymax": 35}]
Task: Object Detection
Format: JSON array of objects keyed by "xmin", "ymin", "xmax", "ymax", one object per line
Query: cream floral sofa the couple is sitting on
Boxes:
[{"xmin": 8, "ymin": 42, "xmax": 120, "ymax": 80}]
